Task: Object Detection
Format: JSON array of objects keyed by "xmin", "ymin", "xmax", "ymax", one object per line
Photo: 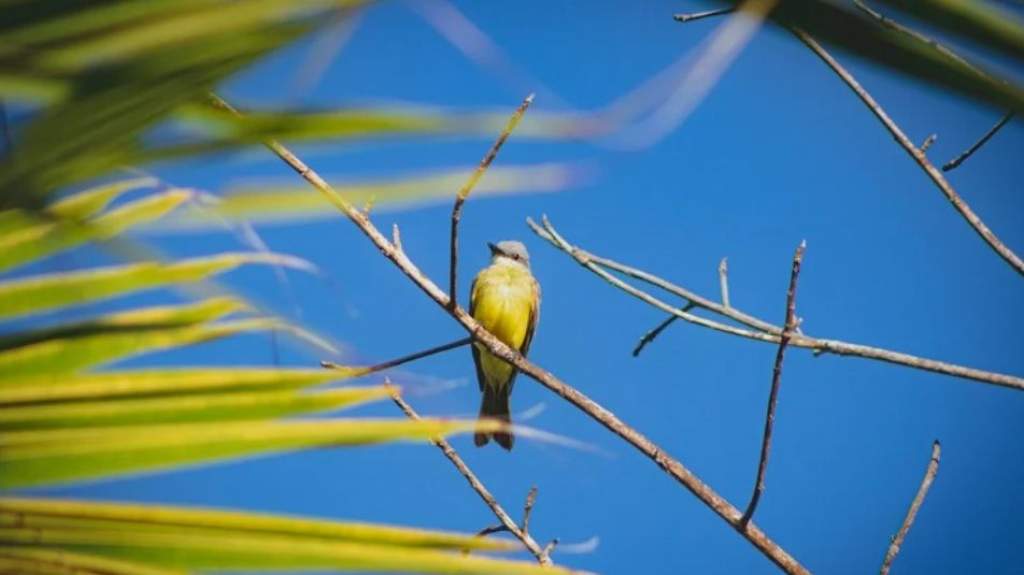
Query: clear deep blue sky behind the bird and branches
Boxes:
[{"xmin": 28, "ymin": 1, "xmax": 1024, "ymax": 573}]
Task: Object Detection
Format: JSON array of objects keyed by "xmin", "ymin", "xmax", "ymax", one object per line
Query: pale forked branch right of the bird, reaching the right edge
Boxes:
[{"xmin": 527, "ymin": 214, "xmax": 1024, "ymax": 390}]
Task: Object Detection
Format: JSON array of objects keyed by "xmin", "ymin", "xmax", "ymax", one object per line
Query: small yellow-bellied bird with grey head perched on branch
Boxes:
[{"xmin": 469, "ymin": 241, "xmax": 541, "ymax": 449}]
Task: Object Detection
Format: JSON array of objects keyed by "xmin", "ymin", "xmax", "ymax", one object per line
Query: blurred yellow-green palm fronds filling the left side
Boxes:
[{"xmin": 0, "ymin": 0, "xmax": 564, "ymax": 574}]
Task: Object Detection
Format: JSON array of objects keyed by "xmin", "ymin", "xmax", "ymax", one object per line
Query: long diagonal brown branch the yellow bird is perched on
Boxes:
[{"xmin": 212, "ymin": 96, "xmax": 808, "ymax": 574}]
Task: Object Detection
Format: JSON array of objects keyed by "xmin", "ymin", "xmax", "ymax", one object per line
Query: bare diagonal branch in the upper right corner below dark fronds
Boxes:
[{"xmin": 791, "ymin": 28, "xmax": 1024, "ymax": 275}]
